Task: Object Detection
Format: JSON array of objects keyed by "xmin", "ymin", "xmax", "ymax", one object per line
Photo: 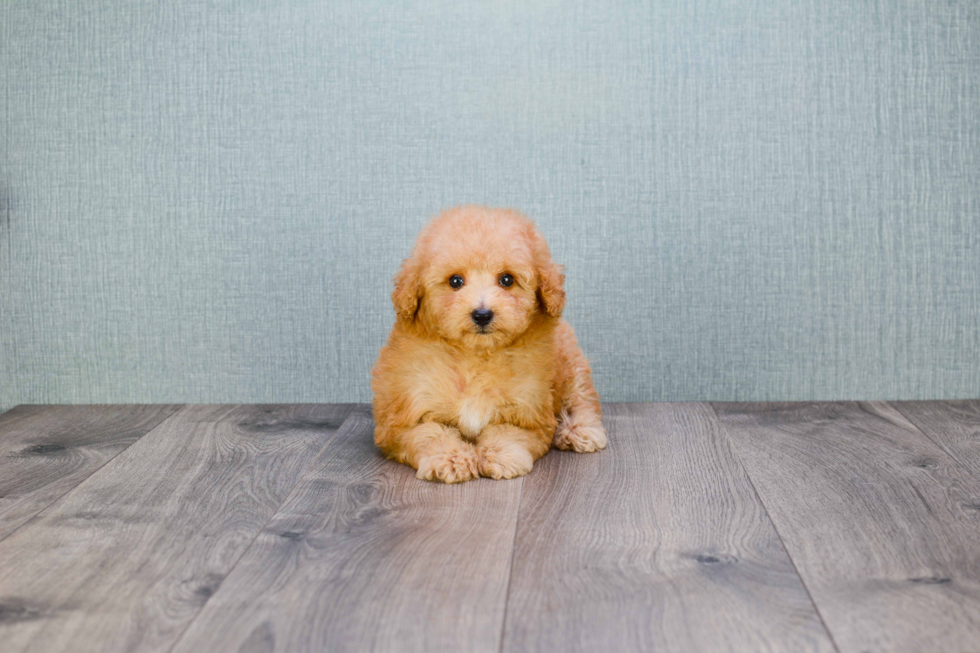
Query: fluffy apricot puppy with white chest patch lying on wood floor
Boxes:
[{"xmin": 371, "ymin": 206, "xmax": 606, "ymax": 483}]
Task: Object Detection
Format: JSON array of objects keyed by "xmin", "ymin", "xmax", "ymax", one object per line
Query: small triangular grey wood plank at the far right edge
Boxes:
[{"xmin": 891, "ymin": 400, "xmax": 980, "ymax": 478}]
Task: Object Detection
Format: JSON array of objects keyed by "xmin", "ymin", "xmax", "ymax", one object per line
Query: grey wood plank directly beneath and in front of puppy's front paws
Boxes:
[{"xmin": 174, "ymin": 407, "xmax": 522, "ymax": 652}]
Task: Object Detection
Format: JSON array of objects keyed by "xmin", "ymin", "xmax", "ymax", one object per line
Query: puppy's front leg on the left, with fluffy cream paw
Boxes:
[{"xmin": 396, "ymin": 422, "xmax": 480, "ymax": 483}]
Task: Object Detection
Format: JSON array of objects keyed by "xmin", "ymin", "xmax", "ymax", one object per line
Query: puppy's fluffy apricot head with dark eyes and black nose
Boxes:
[{"xmin": 392, "ymin": 206, "xmax": 565, "ymax": 349}]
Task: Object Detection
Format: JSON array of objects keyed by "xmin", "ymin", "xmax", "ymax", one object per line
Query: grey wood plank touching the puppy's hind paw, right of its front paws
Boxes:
[{"xmin": 503, "ymin": 404, "xmax": 833, "ymax": 651}]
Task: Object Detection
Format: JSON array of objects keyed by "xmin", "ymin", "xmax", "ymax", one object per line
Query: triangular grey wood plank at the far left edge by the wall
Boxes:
[{"xmin": 0, "ymin": 405, "xmax": 179, "ymax": 540}]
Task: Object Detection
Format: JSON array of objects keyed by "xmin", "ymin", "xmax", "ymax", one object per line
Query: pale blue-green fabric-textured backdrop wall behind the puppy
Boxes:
[{"xmin": 0, "ymin": 0, "xmax": 980, "ymax": 408}]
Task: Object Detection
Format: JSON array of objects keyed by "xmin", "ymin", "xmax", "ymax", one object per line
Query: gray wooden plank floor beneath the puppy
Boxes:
[{"xmin": 0, "ymin": 401, "xmax": 980, "ymax": 653}]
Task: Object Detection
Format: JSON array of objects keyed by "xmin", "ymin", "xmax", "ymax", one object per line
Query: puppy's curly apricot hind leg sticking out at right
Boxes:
[{"xmin": 552, "ymin": 322, "xmax": 606, "ymax": 453}]
